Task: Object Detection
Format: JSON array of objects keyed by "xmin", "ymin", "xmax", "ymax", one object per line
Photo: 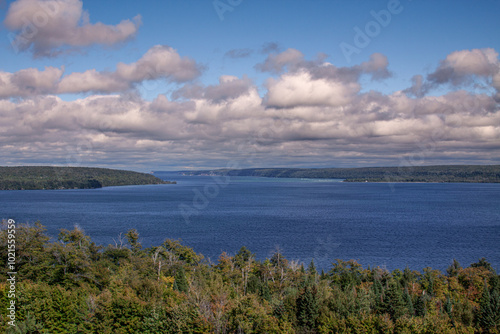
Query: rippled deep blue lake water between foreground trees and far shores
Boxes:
[{"xmin": 0, "ymin": 174, "xmax": 500, "ymax": 270}]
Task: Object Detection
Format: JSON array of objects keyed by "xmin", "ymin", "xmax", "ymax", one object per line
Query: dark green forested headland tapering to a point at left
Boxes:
[{"xmin": 0, "ymin": 166, "xmax": 175, "ymax": 190}]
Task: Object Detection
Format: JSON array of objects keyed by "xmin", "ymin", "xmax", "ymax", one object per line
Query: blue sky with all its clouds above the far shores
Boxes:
[{"xmin": 0, "ymin": 0, "xmax": 500, "ymax": 171}]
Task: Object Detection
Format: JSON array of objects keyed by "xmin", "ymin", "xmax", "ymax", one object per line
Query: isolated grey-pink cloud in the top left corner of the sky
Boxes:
[{"xmin": 4, "ymin": 0, "xmax": 141, "ymax": 57}]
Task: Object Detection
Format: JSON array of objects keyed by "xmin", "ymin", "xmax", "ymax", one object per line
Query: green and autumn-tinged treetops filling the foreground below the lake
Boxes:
[{"xmin": 0, "ymin": 223, "xmax": 500, "ymax": 334}]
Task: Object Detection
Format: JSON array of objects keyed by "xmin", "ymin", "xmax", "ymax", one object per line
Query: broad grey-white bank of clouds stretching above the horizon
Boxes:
[{"xmin": 0, "ymin": 46, "xmax": 500, "ymax": 169}]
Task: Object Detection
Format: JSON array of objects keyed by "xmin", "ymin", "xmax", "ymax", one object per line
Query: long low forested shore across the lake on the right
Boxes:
[{"xmin": 182, "ymin": 165, "xmax": 500, "ymax": 183}]
